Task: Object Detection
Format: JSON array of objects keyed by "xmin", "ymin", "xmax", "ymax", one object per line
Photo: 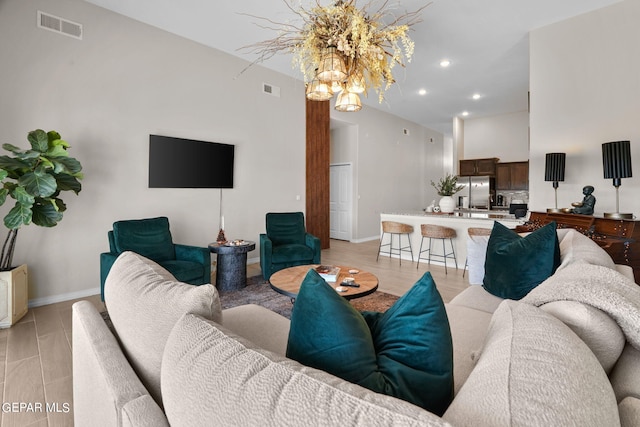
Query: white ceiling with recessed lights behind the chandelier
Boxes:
[{"xmin": 86, "ymin": 0, "xmax": 621, "ymax": 135}]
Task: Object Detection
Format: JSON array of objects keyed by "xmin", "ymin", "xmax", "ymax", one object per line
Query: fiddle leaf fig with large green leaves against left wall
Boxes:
[{"xmin": 0, "ymin": 129, "xmax": 83, "ymax": 326}]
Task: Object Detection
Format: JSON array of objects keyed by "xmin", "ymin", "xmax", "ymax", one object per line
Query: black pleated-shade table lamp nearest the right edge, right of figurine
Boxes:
[{"xmin": 602, "ymin": 141, "xmax": 633, "ymax": 219}]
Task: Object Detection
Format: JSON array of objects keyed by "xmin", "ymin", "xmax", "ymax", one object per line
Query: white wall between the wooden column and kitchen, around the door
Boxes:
[{"xmin": 331, "ymin": 106, "xmax": 443, "ymax": 241}]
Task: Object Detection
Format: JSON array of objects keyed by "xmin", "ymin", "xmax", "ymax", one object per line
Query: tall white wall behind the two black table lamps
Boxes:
[{"xmin": 529, "ymin": 0, "xmax": 640, "ymax": 215}]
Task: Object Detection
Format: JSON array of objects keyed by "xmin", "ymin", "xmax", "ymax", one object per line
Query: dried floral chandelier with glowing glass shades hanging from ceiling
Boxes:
[{"xmin": 246, "ymin": 0, "xmax": 426, "ymax": 111}]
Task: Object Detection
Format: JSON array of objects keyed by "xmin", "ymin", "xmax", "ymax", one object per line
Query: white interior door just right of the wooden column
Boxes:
[{"xmin": 329, "ymin": 164, "xmax": 353, "ymax": 240}]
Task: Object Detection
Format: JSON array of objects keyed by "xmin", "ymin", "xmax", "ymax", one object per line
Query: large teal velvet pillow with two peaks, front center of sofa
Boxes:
[{"xmin": 287, "ymin": 270, "xmax": 453, "ymax": 415}]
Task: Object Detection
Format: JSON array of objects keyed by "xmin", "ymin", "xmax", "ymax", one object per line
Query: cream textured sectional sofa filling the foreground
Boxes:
[{"xmin": 73, "ymin": 230, "xmax": 640, "ymax": 427}]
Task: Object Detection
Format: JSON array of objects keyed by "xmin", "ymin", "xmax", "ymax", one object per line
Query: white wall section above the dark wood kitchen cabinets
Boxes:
[{"xmin": 464, "ymin": 111, "xmax": 529, "ymax": 162}]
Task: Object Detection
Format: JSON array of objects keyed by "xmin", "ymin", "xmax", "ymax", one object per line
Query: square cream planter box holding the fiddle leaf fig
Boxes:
[{"xmin": 0, "ymin": 264, "xmax": 29, "ymax": 328}]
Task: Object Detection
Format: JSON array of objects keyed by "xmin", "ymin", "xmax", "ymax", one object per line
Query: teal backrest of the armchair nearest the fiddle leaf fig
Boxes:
[{"xmin": 113, "ymin": 217, "xmax": 176, "ymax": 262}]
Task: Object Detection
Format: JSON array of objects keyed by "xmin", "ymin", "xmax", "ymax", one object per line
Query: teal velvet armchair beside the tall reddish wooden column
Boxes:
[{"xmin": 260, "ymin": 212, "xmax": 320, "ymax": 280}]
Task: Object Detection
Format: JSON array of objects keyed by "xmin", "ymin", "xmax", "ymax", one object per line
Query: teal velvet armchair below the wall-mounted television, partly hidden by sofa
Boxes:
[{"xmin": 100, "ymin": 217, "xmax": 211, "ymax": 301}]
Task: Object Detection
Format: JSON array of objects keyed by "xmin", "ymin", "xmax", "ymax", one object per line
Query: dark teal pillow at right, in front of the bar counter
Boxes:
[{"xmin": 482, "ymin": 222, "xmax": 560, "ymax": 300}]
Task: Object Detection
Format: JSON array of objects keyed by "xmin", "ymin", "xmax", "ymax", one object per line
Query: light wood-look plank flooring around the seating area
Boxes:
[{"xmin": 0, "ymin": 240, "xmax": 467, "ymax": 427}]
